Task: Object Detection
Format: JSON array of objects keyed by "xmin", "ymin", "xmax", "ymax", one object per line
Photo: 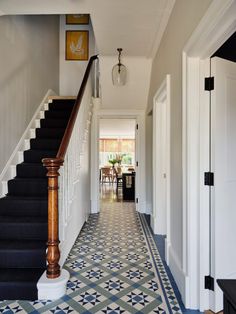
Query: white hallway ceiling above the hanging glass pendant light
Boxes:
[{"xmin": 0, "ymin": 0, "xmax": 175, "ymax": 58}]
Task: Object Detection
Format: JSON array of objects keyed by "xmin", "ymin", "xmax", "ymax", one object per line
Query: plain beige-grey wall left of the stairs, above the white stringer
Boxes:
[{"xmin": 0, "ymin": 16, "xmax": 59, "ymax": 173}]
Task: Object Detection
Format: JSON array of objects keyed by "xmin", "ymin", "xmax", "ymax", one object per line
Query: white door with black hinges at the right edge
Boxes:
[{"xmin": 210, "ymin": 57, "xmax": 236, "ymax": 312}]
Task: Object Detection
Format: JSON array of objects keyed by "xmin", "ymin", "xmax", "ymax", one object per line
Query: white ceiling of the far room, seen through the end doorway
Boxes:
[{"xmin": 99, "ymin": 119, "xmax": 135, "ymax": 139}]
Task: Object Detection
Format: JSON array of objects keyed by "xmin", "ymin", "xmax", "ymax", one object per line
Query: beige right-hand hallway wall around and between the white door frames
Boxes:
[{"xmin": 147, "ymin": 0, "xmax": 211, "ymax": 280}]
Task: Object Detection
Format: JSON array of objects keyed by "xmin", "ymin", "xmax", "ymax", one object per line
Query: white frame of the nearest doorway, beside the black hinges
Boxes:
[{"xmin": 182, "ymin": 0, "xmax": 236, "ymax": 310}]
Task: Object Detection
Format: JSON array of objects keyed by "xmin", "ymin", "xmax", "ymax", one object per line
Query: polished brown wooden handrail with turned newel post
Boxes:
[{"xmin": 42, "ymin": 55, "xmax": 98, "ymax": 278}]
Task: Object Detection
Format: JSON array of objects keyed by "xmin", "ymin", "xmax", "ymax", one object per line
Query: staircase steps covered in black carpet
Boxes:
[{"xmin": 0, "ymin": 99, "xmax": 75, "ymax": 300}]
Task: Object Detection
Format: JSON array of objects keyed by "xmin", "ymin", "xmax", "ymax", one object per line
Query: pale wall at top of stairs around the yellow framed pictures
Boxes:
[{"xmin": 60, "ymin": 15, "xmax": 95, "ymax": 96}]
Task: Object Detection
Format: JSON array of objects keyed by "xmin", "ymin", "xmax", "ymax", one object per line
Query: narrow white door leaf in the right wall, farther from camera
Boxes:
[{"xmin": 153, "ymin": 102, "xmax": 167, "ymax": 234}]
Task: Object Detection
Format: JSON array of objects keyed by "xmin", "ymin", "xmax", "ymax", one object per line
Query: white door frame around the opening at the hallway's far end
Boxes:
[{"xmin": 91, "ymin": 106, "xmax": 147, "ymax": 213}]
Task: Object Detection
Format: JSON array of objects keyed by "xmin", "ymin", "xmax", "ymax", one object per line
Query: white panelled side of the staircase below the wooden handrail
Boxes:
[{"xmin": 59, "ymin": 76, "xmax": 92, "ymax": 265}]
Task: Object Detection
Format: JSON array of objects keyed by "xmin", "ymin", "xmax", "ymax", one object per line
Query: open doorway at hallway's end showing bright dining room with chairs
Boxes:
[{"xmin": 99, "ymin": 118, "xmax": 136, "ymax": 202}]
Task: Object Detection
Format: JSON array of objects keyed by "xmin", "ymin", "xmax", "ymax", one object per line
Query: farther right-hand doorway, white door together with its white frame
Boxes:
[{"xmin": 151, "ymin": 74, "xmax": 170, "ymax": 263}]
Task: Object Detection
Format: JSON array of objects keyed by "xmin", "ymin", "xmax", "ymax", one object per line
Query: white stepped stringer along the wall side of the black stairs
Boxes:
[{"xmin": 0, "ymin": 89, "xmax": 56, "ymax": 197}]
